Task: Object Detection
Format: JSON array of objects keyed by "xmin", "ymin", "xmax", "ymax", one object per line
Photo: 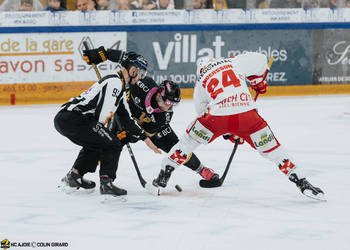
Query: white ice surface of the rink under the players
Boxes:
[{"xmin": 0, "ymin": 95, "xmax": 350, "ymax": 250}]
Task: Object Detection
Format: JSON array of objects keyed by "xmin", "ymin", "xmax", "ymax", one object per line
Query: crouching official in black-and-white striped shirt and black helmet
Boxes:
[{"xmin": 54, "ymin": 50, "xmax": 161, "ymax": 196}]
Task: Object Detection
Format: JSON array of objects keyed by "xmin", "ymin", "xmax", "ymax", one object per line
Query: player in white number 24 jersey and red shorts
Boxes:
[{"xmin": 153, "ymin": 52, "xmax": 324, "ymax": 200}]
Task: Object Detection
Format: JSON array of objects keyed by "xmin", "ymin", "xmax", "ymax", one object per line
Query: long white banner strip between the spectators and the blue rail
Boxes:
[{"xmin": 0, "ymin": 8, "xmax": 350, "ymax": 28}]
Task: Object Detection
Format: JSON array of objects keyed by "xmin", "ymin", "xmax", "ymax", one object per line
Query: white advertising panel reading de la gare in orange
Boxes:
[{"xmin": 0, "ymin": 32, "xmax": 126, "ymax": 84}]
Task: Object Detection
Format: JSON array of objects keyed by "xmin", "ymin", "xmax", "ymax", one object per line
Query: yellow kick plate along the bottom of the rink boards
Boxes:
[{"xmin": 0, "ymin": 82, "xmax": 350, "ymax": 105}]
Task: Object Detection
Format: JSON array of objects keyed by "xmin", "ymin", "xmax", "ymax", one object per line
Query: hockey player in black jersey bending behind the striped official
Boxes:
[{"xmin": 84, "ymin": 47, "xmax": 219, "ymax": 187}]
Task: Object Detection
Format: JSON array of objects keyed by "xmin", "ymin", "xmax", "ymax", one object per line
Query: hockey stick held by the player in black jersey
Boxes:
[{"xmin": 83, "ymin": 41, "xmax": 159, "ymax": 195}]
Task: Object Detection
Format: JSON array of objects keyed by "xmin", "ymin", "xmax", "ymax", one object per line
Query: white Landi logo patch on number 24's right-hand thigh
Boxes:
[{"xmin": 250, "ymin": 126, "xmax": 277, "ymax": 151}]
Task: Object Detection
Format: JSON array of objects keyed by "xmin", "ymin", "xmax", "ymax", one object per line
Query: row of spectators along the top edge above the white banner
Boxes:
[{"xmin": 0, "ymin": 0, "xmax": 350, "ymax": 11}]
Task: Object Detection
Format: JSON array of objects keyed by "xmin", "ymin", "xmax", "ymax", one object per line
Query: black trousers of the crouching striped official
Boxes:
[{"xmin": 54, "ymin": 110, "xmax": 123, "ymax": 179}]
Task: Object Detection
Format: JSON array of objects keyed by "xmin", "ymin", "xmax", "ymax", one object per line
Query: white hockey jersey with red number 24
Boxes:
[{"xmin": 193, "ymin": 52, "xmax": 267, "ymax": 116}]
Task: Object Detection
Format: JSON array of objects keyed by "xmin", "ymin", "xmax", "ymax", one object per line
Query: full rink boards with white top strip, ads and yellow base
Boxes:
[{"xmin": 0, "ymin": 9, "xmax": 350, "ymax": 105}]
